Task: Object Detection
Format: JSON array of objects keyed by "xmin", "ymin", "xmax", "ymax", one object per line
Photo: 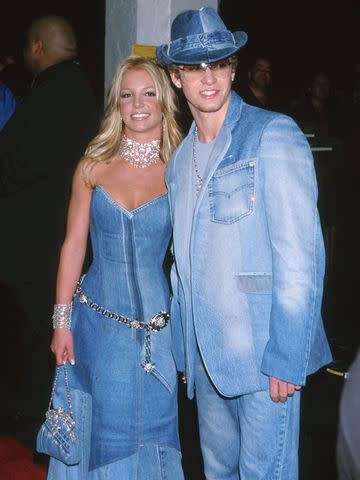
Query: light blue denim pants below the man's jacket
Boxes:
[{"xmin": 195, "ymin": 355, "xmax": 300, "ymax": 480}]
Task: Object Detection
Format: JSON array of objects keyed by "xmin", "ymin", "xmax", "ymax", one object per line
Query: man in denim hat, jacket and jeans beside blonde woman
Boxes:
[{"xmin": 157, "ymin": 7, "xmax": 331, "ymax": 480}]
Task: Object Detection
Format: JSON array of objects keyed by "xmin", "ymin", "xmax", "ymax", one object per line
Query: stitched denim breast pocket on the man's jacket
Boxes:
[{"xmin": 209, "ymin": 159, "xmax": 255, "ymax": 224}]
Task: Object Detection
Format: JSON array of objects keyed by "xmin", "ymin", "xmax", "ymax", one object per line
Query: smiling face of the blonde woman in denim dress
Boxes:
[{"xmin": 120, "ymin": 68, "xmax": 162, "ymax": 142}]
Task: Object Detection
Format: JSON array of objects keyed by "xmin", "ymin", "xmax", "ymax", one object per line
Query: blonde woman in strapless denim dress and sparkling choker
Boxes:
[{"xmin": 49, "ymin": 57, "xmax": 183, "ymax": 480}]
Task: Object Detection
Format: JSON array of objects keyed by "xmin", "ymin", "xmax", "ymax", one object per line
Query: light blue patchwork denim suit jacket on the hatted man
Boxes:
[{"xmin": 166, "ymin": 92, "xmax": 331, "ymax": 397}]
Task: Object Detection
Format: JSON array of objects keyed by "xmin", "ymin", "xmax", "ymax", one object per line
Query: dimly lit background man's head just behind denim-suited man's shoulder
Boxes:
[{"xmin": 239, "ymin": 57, "xmax": 273, "ymax": 110}]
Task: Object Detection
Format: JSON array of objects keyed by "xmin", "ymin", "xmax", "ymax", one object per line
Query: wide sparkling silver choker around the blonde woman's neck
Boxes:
[{"xmin": 119, "ymin": 135, "xmax": 161, "ymax": 168}]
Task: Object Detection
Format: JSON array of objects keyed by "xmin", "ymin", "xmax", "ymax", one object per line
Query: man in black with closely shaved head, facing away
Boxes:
[{"xmin": 0, "ymin": 15, "xmax": 98, "ymax": 424}]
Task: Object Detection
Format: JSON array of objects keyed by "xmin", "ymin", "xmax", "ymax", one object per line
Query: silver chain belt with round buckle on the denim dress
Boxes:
[{"xmin": 75, "ymin": 280, "xmax": 170, "ymax": 373}]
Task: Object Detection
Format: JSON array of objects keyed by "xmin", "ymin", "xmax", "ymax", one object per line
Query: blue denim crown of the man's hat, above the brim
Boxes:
[{"xmin": 171, "ymin": 6, "xmax": 227, "ymax": 41}]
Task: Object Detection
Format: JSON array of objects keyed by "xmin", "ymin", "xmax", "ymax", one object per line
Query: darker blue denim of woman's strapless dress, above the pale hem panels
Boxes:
[{"xmin": 47, "ymin": 185, "xmax": 180, "ymax": 478}]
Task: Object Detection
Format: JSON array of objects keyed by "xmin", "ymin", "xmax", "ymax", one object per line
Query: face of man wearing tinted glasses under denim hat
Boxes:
[{"xmin": 171, "ymin": 59, "xmax": 234, "ymax": 115}]
